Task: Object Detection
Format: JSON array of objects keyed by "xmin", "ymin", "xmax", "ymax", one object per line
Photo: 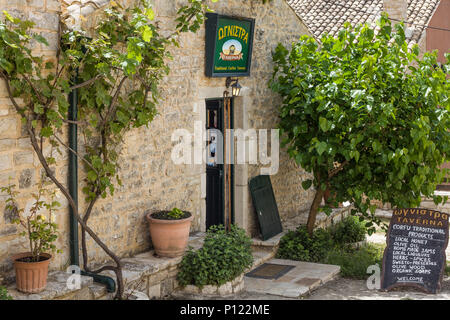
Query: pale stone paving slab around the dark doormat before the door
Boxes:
[{"xmin": 244, "ymin": 259, "xmax": 341, "ymax": 298}]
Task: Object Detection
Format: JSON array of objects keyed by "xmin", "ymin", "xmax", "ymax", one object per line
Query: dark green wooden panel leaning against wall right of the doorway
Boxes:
[{"xmin": 249, "ymin": 175, "xmax": 283, "ymax": 240}]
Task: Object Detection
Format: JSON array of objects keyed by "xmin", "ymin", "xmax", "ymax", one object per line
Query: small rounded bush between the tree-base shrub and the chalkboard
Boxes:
[{"xmin": 330, "ymin": 216, "xmax": 367, "ymax": 244}]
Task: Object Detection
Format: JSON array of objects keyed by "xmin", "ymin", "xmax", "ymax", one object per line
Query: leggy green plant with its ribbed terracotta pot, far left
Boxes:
[{"xmin": 1, "ymin": 182, "xmax": 60, "ymax": 293}]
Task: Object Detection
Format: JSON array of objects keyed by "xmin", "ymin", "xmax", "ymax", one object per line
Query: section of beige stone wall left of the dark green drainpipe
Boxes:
[{"xmin": 0, "ymin": 0, "xmax": 68, "ymax": 280}]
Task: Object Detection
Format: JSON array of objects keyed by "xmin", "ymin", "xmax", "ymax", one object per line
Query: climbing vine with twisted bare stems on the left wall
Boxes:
[{"xmin": 0, "ymin": 0, "xmax": 211, "ymax": 298}]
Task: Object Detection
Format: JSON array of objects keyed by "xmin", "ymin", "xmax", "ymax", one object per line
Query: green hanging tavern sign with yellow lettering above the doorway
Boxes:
[{"xmin": 205, "ymin": 13, "xmax": 255, "ymax": 77}]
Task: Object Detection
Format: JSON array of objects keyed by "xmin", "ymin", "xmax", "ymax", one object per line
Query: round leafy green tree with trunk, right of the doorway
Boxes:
[{"xmin": 270, "ymin": 15, "xmax": 450, "ymax": 233}]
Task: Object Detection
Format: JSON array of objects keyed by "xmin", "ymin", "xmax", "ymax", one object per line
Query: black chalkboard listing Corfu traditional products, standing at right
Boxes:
[{"xmin": 381, "ymin": 208, "xmax": 448, "ymax": 293}]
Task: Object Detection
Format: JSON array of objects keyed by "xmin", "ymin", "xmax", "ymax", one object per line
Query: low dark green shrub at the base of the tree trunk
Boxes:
[{"xmin": 277, "ymin": 226, "xmax": 334, "ymax": 262}]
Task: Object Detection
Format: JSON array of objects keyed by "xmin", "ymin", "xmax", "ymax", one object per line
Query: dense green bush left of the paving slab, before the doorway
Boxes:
[{"xmin": 177, "ymin": 225, "xmax": 253, "ymax": 287}]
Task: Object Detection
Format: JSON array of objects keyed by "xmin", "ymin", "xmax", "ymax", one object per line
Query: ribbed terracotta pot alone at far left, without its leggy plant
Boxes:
[{"xmin": 11, "ymin": 252, "xmax": 52, "ymax": 293}]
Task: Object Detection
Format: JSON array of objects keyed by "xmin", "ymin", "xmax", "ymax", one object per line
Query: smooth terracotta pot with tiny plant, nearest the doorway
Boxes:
[{"xmin": 146, "ymin": 208, "xmax": 194, "ymax": 257}]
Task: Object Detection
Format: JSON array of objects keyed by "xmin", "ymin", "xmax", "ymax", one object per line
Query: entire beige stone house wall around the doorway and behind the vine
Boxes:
[{"xmin": 0, "ymin": 0, "xmax": 313, "ymax": 280}]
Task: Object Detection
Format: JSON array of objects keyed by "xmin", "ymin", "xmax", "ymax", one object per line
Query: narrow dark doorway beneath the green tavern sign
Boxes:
[{"xmin": 206, "ymin": 99, "xmax": 234, "ymax": 229}]
